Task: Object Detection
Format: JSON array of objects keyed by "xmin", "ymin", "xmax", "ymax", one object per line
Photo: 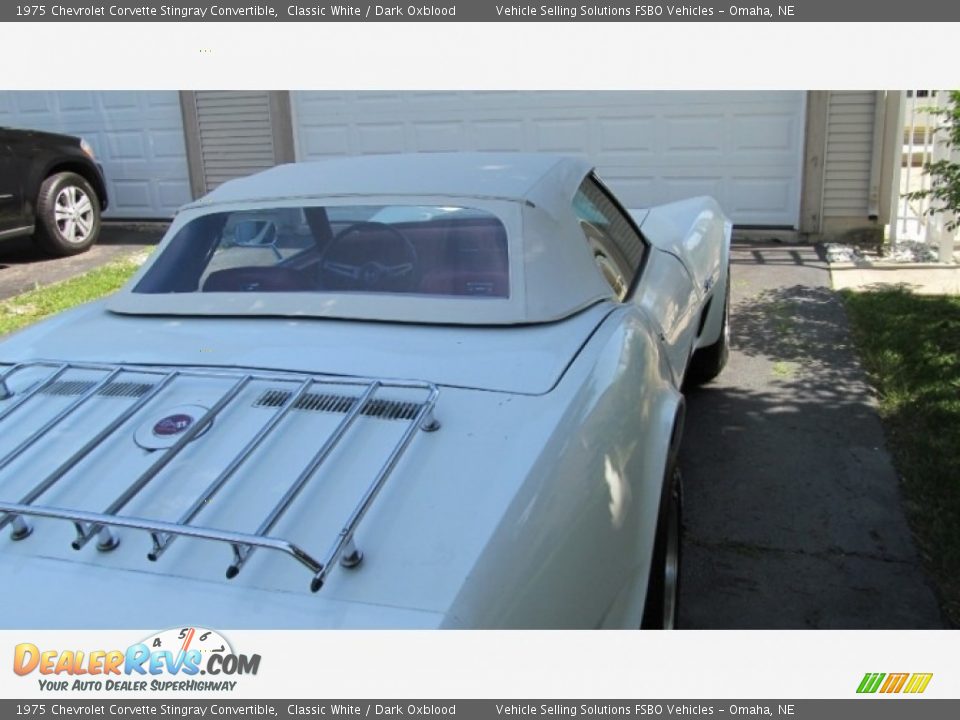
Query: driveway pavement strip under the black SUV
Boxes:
[{"xmin": 0, "ymin": 222, "xmax": 166, "ymax": 300}]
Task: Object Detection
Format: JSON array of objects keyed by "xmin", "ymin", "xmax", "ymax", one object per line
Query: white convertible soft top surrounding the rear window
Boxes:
[{"xmin": 108, "ymin": 158, "xmax": 612, "ymax": 325}]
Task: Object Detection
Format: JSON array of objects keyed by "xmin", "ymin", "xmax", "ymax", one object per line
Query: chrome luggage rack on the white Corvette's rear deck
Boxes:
[{"xmin": 0, "ymin": 361, "xmax": 440, "ymax": 592}]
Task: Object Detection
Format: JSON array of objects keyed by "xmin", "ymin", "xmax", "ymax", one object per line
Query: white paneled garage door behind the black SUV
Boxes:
[{"xmin": 0, "ymin": 91, "xmax": 190, "ymax": 218}]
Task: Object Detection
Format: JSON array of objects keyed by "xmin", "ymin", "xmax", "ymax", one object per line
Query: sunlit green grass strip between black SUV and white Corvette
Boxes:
[{"xmin": 0, "ymin": 258, "xmax": 142, "ymax": 335}]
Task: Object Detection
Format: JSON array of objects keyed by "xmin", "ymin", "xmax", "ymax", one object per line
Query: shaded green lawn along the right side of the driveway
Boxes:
[{"xmin": 843, "ymin": 290, "xmax": 960, "ymax": 626}]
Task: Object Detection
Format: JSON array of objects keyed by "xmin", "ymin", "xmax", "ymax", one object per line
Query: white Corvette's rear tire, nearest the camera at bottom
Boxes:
[{"xmin": 640, "ymin": 459, "xmax": 683, "ymax": 630}]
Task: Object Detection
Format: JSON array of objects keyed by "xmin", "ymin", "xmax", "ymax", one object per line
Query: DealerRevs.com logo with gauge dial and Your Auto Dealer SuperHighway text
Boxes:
[{"xmin": 13, "ymin": 627, "xmax": 260, "ymax": 692}]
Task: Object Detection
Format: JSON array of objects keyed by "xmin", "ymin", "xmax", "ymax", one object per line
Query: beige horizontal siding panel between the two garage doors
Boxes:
[{"xmin": 194, "ymin": 90, "xmax": 275, "ymax": 191}]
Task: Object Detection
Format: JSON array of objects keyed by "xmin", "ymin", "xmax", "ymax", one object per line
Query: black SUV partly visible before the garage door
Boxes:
[{"xmin": 0, "ymin": 127, "xmax": 107, "ymax": 255}]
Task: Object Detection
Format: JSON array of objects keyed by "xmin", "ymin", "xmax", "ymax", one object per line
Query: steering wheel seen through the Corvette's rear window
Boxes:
[{"xmin": 320, "ymin": 220, "xmax": 420, "ymax": 292}]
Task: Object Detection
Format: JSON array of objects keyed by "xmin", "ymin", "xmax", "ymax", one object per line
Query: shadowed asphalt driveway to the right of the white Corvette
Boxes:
[{"xmin": 680, "ymin": 243, "xmax": 944, "ymax": 628}]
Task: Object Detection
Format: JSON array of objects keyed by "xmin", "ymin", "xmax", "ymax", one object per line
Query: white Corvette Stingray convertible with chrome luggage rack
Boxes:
[{"xmin": 0, "ymin": 154, "xmax": 731, "ymax": 628}]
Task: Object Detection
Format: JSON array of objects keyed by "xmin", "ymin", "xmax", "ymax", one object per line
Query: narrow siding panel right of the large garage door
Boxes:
[{"xmin": 823, "ymin": 91, "xmax": 876, "ymax": 220}]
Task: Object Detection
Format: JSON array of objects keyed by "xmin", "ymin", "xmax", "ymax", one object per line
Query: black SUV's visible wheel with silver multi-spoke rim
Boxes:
[{"xmin": 34, "ymin": 172, "xmax": 100, "ymax": 257}]
